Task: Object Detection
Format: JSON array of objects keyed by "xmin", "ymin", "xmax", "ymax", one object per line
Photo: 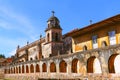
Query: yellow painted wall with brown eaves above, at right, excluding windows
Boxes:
[{"xmin": 72, "ymin": 24, "xmax": 120, "ymax": 52}]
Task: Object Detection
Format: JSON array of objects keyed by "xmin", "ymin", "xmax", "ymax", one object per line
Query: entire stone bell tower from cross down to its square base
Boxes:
[{"xmin": 43, "ymin": 11, "xmax": 63, "ymax": 57}]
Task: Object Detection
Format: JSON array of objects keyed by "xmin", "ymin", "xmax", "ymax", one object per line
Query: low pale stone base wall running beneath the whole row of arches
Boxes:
[{"xmin": 5, "ymin": 73, "xmax": 120, "ymax": 80}]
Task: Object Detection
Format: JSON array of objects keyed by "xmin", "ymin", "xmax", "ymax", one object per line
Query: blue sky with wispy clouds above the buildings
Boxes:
[{"xmin": 0, "ymin": 0, "xmax": 120, "ymax": 57}]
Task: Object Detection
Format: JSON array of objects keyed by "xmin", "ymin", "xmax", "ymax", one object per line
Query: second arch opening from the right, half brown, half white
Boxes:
[{"xmin": 87, "ymin": 56, "xmax": 102, "ymax": 73}]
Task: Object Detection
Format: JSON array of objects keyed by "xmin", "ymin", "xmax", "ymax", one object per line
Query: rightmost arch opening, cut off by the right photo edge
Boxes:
[{"xmin": 108, "ymin": 54, "xmax": 120, "ymax": 73}]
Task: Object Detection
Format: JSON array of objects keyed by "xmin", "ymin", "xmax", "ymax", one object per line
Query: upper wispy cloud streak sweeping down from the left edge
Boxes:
[{"xmin": 0, "ymin": 6, "xmax": 36, "ymax": 39}]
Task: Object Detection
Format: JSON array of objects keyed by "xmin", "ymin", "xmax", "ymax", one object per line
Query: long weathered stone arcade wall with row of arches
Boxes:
[{"xmin": 5, "ymin": 45, "xmax": 120, "ymax": 80}]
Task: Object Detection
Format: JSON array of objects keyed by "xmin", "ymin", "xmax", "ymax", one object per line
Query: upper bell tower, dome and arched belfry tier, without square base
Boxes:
[{"xmin": 45, "ymin": 11, "xmax": 62, "ymax": 43}]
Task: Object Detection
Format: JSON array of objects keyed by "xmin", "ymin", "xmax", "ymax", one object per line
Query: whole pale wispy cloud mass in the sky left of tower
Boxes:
[{"xmin": 0, "ymin": 5, "xmax": 43, "ymax": 56}]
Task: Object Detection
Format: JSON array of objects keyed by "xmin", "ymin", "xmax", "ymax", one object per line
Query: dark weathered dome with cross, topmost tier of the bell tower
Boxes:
[{"xmin": 46, "ymin": 11, "xmax": 62, "ymax": 31}]
